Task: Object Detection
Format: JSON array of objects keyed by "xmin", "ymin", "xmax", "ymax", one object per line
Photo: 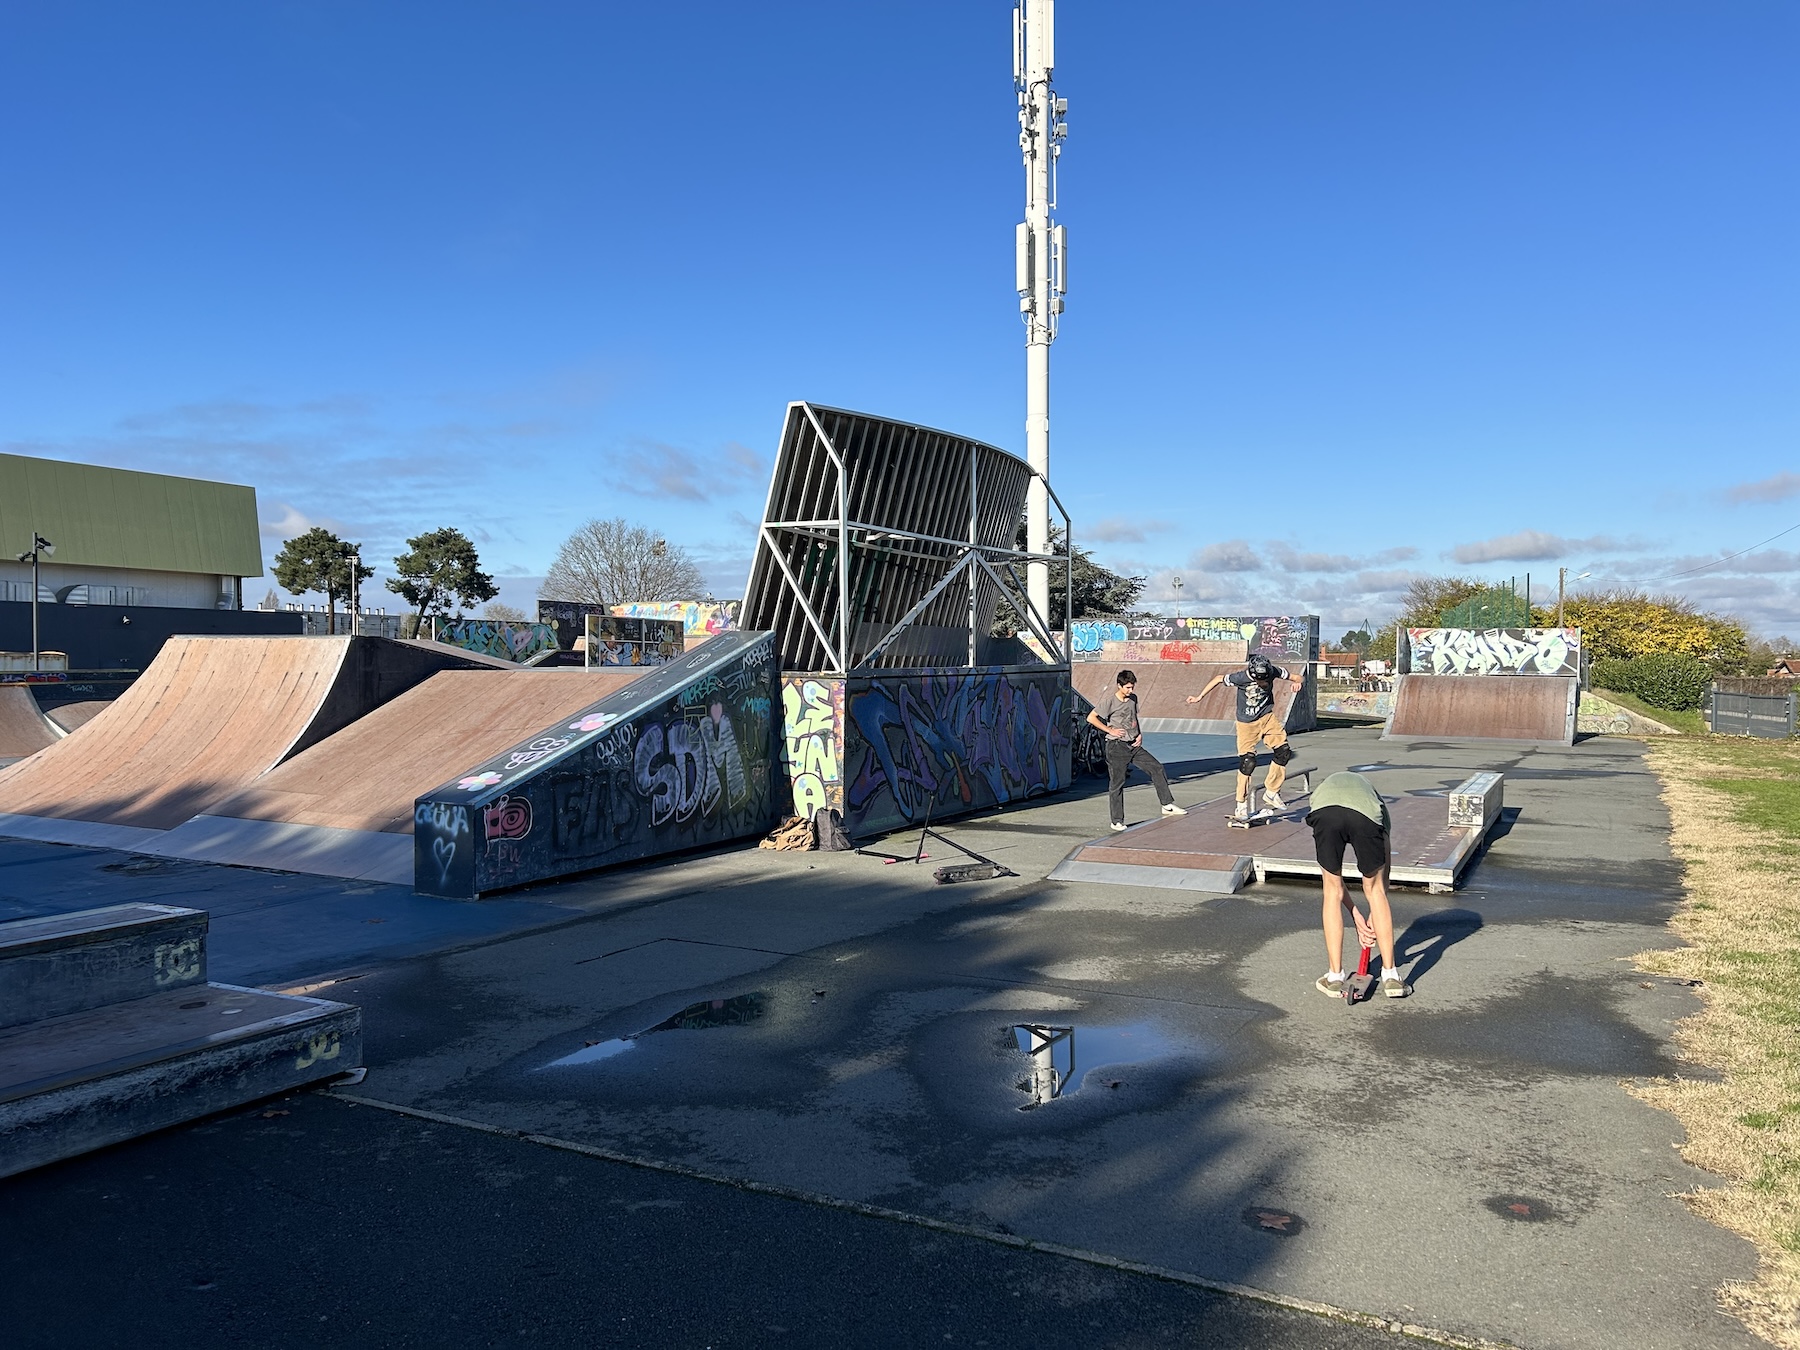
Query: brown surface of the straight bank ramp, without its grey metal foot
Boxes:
[{"xmin": 209, "ymin": 668, "xmax": 653, "ymax": 835}]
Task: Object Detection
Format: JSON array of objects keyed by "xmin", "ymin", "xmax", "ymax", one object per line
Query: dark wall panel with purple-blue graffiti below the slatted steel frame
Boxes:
[{"xmin": 842, "ymin": 666, "xmax": 1075, "ymax": 835}]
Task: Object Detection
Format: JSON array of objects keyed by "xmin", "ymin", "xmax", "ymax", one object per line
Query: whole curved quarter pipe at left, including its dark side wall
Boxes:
[{"xmin": 0, "ymin": 637, "xmax": 500, "ymax": 850}]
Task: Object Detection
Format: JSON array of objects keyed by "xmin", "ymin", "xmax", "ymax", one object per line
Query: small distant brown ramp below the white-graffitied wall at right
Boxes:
[{"xmin": 1381, "ymin": 675, "xmax": 1580, "ymax": 745}]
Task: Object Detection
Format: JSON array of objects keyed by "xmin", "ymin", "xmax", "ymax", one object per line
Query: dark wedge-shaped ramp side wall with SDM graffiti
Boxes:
[{"xmin": 412, "ymin": 632, "xmax": 779, "ymax": 896}]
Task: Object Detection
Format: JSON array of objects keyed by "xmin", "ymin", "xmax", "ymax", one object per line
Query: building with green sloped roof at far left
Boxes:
[{"xmin": 0, "ymin": 455, "xmax": 263, "ymax": 610}]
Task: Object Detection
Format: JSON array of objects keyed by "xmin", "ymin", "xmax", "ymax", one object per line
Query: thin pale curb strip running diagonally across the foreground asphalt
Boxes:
[{"xmin": 331, "ymin": 1085, "xmax": 1517, "ymax": 1350}]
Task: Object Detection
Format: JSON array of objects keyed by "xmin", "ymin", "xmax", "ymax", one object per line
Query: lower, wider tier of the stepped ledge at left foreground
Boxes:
[{"xmin": 0, "ymin": 985, "xmax": 362, "ymax": 1177}]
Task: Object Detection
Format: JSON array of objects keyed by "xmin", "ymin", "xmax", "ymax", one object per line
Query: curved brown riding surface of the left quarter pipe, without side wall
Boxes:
[{"xmin": 0, "ymin": 637, "xmax": 361, "ymax": 830}]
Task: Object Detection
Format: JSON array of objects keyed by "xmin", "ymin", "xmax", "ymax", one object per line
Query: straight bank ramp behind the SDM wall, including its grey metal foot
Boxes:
[{"xmin": 142, "ymin": 666, "xmax": 643, "ymax": 886}]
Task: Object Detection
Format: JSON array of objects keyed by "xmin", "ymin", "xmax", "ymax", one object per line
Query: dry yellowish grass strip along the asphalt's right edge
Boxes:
[{"xmin": 1633, "ymin": 736, "xmax": 1800, "ymax": 1350}]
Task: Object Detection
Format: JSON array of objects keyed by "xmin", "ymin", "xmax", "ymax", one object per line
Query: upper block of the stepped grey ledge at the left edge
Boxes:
[{"xmin": 0, "ymin": 904, "xmax": 207, "ymax": 1028}]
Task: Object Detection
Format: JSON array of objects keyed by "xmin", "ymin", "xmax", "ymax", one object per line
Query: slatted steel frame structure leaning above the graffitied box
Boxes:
[{"xmin": 742, "ymin": 401, "xmax": 1075, "ymax": 677}]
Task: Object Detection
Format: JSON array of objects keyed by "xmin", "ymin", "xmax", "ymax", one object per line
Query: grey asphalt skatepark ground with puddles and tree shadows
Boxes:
[{"xmin": 0, "ymin": 731, "xmax": 1753, "ymax": 1346}]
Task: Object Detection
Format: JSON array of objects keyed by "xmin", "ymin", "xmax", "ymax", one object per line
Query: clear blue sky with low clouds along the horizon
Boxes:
[{"xmin": 0, "ymin": 0, "xmax": 1800, "ymax": 637}]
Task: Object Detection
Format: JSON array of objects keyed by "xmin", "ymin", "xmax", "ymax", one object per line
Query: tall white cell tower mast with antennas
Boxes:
[{"xmin": 1013, "ymin": 0, "xmax": 1069, "ymax": 625}]
